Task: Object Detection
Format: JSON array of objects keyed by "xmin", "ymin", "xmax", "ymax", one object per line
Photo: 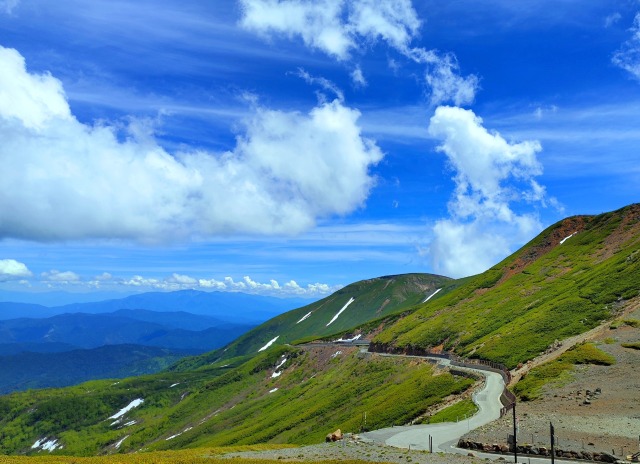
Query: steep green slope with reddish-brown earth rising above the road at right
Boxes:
[{"xmin": 374, "ymin": 204, "xmax": 640, "ymax": 367}]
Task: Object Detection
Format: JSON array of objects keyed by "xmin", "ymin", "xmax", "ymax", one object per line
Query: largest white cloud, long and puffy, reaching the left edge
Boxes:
[{"xmin": 0, "ymin": 47, "xmax": 383, "ymax": 242}]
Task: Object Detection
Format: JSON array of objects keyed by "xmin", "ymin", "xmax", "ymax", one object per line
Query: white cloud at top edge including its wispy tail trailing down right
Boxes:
[{"xmin": 241, "ymin": 0, "xmax": 479, "ymax": 106}]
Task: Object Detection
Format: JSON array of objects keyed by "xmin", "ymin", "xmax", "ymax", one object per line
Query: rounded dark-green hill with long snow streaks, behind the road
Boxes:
[{"xmin": 170, "ymin": 274, "xmax": 456, "ymax": 370}]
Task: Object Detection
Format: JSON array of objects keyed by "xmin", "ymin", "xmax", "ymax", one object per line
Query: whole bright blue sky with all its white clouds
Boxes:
[{"xmin": 0, "ymin": 0, "xmax": 640, "ymax": 297}]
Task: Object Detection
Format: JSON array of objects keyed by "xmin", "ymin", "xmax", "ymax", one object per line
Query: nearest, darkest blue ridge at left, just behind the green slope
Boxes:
[{"xmin": 0, "ymin": 345, "xmax": 188, "ymax": 394}]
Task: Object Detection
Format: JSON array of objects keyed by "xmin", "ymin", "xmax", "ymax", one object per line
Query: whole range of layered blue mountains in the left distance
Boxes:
[{"xmin": 0, "ymin": 290, "xmax": 307, "ymax": 393}]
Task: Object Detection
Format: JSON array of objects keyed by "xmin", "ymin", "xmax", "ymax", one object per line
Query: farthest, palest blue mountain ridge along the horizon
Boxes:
[{"xmin": 0, "ymin": 290, "xmax": 308, "ymax": 325}]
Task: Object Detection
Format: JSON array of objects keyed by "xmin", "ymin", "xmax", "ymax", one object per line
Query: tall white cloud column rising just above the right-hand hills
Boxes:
[{"xmin": 429, "ymin": 106, "xmax": 545, "ymax": 277}]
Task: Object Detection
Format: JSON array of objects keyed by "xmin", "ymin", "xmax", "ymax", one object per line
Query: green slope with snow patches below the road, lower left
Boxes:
[{"xmin": 0, "ymin": 347, "xmax": 471, "ymax": 455}]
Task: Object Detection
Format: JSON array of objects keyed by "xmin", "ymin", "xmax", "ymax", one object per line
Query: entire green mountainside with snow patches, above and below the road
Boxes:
[{"xmin": 0, "ymin": 205, "xmax": 640, "ymax": 454}]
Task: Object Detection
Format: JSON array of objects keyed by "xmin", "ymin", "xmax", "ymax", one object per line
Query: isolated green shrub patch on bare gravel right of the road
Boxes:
[{"xmin": 513, "ymin": 343, "xmax": 616, "ymax": 401}]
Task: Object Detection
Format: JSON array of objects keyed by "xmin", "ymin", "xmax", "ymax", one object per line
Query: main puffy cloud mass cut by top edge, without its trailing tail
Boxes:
[{"xmin": 241, "ymin": 0, "xmax": 420, "ymax": 60}]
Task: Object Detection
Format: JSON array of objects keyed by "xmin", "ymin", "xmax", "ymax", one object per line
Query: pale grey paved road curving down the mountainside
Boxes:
[{"xmin": 361, "ymin": 359, "xmax": 504, "ymax": 453}]
